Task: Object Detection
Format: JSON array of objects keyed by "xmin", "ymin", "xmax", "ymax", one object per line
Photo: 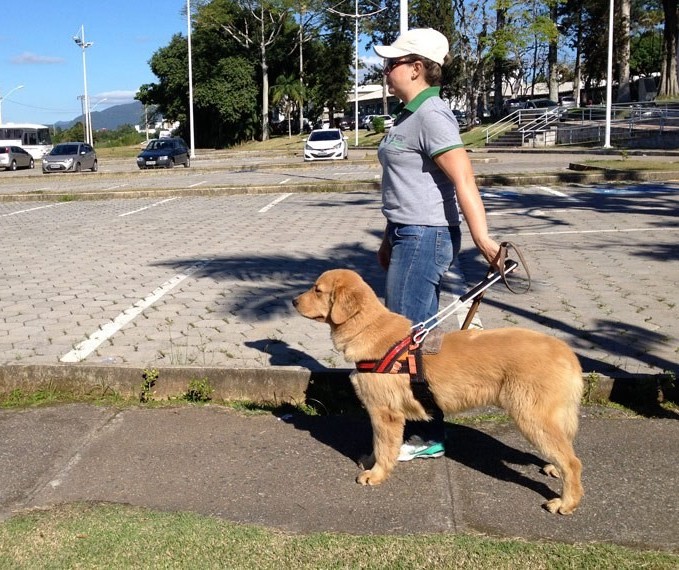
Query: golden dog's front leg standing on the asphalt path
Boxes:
[{"xmin": 356, "ymin": 408, "xmax": 405, "ymax": 485}]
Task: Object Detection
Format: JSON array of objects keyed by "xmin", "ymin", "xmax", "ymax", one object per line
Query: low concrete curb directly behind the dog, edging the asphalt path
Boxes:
[{"xmin": 0, "ymin": 364, "xmax": 679, "ymax": 410}]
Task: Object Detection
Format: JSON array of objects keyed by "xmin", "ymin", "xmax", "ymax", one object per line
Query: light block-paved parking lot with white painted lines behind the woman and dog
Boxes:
[{"xmin": 0, "ymin": 158, "xmax": 679, "ymax": 375}]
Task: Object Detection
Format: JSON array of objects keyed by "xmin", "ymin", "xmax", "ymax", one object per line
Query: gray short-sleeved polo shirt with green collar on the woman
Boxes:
[{"xmin": 377, "ymin": 87, "xmax": 464, "ymax": 226}]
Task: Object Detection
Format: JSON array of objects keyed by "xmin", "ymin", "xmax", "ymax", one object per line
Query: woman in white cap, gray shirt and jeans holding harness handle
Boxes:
[{"xmin": 374, "ymin": 28, "xmax": 499, "ymax": 461}]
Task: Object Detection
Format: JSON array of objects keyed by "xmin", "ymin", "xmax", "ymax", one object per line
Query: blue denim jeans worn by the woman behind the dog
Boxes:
[{"xmin": 385, "ymin": 223, "xmax": 461, "ymax": 443}]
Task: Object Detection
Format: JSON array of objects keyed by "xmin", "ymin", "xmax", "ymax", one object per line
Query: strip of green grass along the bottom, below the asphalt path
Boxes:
[{"xmin": 0, "ymin": 503, "xmax": 679, "ymax": 570}]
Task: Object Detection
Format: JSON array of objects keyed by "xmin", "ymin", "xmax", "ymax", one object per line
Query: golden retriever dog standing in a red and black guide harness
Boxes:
[{"xmin": 293, "ymin": 269, "xmax": 583, "ymax": 515}]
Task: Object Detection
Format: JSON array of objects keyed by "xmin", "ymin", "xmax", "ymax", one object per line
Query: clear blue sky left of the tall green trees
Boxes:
[{"xmin": 0, "ymin": 0, "xmax": 187, "ymax": 125}]
